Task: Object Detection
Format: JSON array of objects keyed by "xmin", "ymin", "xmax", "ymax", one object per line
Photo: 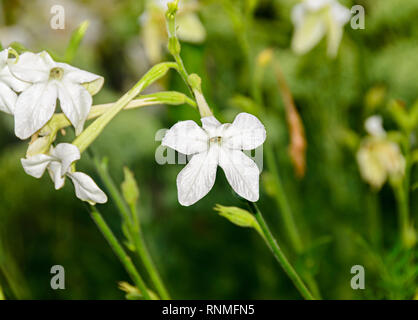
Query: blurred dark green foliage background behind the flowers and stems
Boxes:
[{"xmin": 0, "ymin": 0, "xmax": 418, "ymax": 299}]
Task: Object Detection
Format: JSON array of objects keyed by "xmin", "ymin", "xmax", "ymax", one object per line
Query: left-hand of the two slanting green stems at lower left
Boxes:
[{"xmin": 91, "ymin": 207, "xmax": 151, "ymax": 300}]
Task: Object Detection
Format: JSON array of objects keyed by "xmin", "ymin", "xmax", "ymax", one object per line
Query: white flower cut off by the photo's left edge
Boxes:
[{"xmin": 0, "ymin": 49, "xmax": 29, "ymax": 114}]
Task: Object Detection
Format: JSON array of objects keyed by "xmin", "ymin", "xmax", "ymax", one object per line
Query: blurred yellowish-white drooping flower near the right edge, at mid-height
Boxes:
[{"xmin": 357, "ymin": 116, "xmax": 405, "ymax": 189}]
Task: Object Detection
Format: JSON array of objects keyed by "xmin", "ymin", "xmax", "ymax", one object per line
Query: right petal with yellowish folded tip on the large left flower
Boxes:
[{"xmin": 57, "ymin": 63, "xmax": 104, "ymax": 96}]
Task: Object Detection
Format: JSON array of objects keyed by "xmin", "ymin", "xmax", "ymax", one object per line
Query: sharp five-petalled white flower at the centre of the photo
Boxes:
[{"xmin": 162, "ymin": 113, "xmax": 266, "ymax": 206}]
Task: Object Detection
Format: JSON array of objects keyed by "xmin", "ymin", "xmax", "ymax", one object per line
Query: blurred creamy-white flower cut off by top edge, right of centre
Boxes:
[{"xmin": 292, "ymin": 0, "xmax": 351, "ymax": 57}]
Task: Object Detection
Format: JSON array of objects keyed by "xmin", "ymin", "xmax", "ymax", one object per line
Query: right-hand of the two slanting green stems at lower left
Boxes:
[{"xmin": 94, "ymin": 157, "xmax": 170, "ymax": 300}]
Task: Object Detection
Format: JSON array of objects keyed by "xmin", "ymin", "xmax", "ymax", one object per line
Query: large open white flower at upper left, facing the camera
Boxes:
[{"xmin": 9, "ymin": 51, "xmax": 103, "ymax": 139}]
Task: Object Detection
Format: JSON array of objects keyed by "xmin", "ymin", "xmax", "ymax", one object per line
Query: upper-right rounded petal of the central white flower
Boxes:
[{"xmin": 222, "ymin": 112, "xmax": 266, "ymax": 150}]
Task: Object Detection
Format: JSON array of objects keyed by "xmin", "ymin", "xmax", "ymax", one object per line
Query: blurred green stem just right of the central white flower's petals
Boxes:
[{"xmin": 265, "ymin": 143, "xmax": 303, "ymax": 253}]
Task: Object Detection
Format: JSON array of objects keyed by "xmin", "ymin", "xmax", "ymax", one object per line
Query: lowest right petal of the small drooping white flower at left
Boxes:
[{"xmin": 67, "ymin": 172, "xmax": 107, "ymax": 204}]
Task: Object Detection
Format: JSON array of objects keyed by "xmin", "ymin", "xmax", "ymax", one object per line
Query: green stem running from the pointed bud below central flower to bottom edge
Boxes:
[{"xmin": 248, "ymin": 201, "xmax": 315, "ymax": 300}]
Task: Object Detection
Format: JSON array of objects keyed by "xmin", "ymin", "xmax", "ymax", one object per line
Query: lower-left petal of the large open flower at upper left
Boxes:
[{"xmin": 14, "ymin": 82, "xmax": 57, "ymax": 140}]
